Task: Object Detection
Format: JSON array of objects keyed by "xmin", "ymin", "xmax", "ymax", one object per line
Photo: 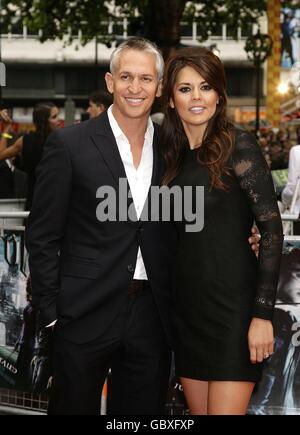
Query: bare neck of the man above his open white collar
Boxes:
[{"xmin": 112, "ymin": 106, "xmax": 149, "ymax": 142}]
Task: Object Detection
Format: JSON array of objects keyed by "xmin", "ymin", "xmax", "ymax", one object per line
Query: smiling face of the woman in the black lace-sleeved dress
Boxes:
[{"xmin": 170, "ymin": 66, "xmax": 219, "ymax": 131}]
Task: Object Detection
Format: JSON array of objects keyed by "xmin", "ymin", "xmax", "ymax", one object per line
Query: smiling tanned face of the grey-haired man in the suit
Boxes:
[{"xmin": 105, "ymin": 50, "xmax": 161, "ymax": 123}]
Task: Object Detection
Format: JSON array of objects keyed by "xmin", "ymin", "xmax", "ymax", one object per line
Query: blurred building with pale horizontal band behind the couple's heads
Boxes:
[{"xmin": 2, "ymin": 18, "xmax": 292, "ymax": 122}]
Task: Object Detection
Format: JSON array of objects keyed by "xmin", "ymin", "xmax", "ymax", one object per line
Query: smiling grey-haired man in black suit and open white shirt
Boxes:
[{"xmin": 27, "ymin": 38, "xmax": 260, "ymax": 415}]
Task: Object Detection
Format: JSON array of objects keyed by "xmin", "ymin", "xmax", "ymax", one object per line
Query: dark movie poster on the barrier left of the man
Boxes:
[{"xmin": 0, "ymin": 231, "xmax": 50, "ymax": 392}]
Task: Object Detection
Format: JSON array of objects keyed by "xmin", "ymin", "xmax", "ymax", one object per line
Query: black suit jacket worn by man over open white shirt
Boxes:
[{"xmin": 26, "ymin": 112, "xmax": 176, "ymax": 343}]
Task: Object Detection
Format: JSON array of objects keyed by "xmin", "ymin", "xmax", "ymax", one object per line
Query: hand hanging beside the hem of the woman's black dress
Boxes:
[{"xmin": 248, "ymin": 317, "xmax": 274, "ymax": 364}]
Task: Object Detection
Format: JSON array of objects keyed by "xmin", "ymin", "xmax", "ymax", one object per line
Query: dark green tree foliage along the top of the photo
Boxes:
[{"xmin": 0, "ymin": 0, "xmax": 268, "ymax": 48}]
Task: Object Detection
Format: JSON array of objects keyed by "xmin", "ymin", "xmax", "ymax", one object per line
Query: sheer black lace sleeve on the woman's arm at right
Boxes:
[{"xmin": 233, "ymin": 132, "xmax": 283, "ymax": 320}]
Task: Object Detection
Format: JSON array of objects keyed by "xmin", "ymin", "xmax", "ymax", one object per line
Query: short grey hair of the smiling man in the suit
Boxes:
[{"xmin": 109, "ymin": 38, "xmax": 164, "ymax": 80}]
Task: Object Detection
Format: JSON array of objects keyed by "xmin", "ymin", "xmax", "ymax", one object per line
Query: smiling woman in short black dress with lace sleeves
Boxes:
[{"xmin": 162, "ymin": 48, "xmax": 283, "ymax": 414}]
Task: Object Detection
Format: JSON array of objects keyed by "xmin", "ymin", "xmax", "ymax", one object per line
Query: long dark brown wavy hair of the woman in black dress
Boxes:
[{"xmin": 161, "ymin": 47, "xmax": 234, "ymax": 190}]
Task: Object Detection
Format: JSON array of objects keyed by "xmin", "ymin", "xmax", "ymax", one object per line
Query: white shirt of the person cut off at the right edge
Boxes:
[{"xmin": 281, "ymin": 145, "xmax": 300, "ymax": 214}]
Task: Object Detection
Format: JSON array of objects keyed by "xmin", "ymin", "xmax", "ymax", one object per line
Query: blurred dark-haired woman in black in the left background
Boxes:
[{"xmin": 0, "ymin": 103, "xmax": 60, "ymax": 211}]
